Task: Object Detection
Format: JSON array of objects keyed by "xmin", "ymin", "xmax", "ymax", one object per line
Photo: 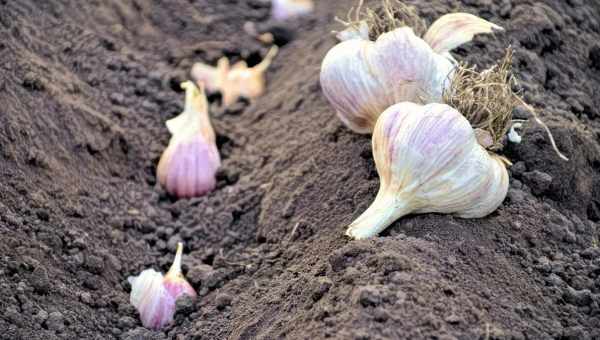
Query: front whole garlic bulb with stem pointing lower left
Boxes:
[{"xmin": 346, "ymin": 102, "xmax": 508, "ymax": 239}]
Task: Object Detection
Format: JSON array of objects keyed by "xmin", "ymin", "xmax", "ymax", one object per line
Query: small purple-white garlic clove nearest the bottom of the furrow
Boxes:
[{"xmin": 127, "ymin": 243, "xmax": 197, "ymax": 329}]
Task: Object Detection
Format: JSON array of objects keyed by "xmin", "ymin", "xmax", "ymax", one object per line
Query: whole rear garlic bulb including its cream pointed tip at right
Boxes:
[{"xmin": 320, "ymin": 13, "xmax": 502, "ymax": 133}]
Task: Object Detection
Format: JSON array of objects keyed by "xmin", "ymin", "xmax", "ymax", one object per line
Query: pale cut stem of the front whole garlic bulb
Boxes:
[{"xmin": 346, "ymin": 190, "xmax": 413, "ymax": 240}]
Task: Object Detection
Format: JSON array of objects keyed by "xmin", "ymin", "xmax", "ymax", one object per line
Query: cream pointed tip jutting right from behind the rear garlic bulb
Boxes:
[{"xmin": 423, "ymin": 13, "xmax": 504, "ymax": 54}]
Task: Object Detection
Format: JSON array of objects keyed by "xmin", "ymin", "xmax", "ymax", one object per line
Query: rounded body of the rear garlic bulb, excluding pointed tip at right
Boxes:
[{"xmin": 320, "ymin": 27, "xmax": 454, "ymax": 133}]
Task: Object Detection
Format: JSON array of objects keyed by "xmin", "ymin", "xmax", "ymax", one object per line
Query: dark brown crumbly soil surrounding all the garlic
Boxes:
[{"xmin": 0, "ymin": 0, "xmax": 600, "ymax": 340}]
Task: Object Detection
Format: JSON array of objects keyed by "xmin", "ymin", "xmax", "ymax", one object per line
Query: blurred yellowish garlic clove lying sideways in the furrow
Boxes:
[{"xmin": 191, "ymin": 46, "xmax": 278, "ymax": 106}]
